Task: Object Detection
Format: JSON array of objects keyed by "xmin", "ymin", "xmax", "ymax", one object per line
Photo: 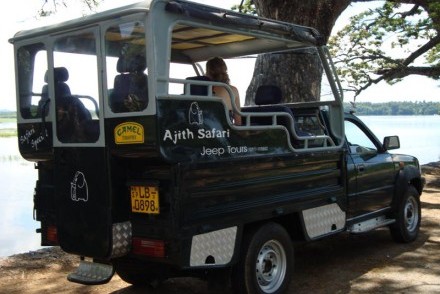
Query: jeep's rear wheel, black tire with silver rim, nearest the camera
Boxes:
[{"xmin": 231, "ymin": 223, "xmax": 294, "ymax": 294}]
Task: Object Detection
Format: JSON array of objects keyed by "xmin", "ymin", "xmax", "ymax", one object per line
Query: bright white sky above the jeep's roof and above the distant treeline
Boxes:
[{"xmin": 0, "ymin": 0, "xmax": 440, "ymax": 110}]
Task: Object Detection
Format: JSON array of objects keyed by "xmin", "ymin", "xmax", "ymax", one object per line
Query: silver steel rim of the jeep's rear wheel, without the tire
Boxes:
[{"xmin": 255, "ymin": 240, "xmax": 287, "ymax": 293}]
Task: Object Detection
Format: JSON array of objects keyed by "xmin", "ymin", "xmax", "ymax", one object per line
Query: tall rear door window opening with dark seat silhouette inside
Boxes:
[{"xmin": 53, "ymin": 32, "xmax": 99, "ymax": 143}]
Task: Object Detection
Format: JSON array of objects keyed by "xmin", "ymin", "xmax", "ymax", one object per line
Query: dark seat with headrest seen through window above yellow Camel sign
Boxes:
[{"xmin": 110, "ymin": 55, "xmax": 148, "ymax": 112}]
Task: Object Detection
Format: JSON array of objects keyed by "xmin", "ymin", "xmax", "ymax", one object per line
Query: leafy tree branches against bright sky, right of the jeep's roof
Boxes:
[{"xmin": 329, "ymin": 0, "xmax": 440, "ymax": 97}]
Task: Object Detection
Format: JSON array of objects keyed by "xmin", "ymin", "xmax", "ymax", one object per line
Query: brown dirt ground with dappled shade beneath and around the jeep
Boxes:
[{"xmin": 0, "ymin": 163, "xmax": 440, "ymax": 294}]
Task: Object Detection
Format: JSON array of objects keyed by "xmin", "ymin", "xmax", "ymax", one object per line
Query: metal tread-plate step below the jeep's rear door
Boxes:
[{"xmin": 67, "ymin": 260, "xmax": 115, "ymax": 285}]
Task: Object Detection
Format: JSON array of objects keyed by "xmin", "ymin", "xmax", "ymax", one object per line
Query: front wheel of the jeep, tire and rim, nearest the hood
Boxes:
[{"xmin": 390, "ymin": 186, "xmax": 422, "ymax": 243}]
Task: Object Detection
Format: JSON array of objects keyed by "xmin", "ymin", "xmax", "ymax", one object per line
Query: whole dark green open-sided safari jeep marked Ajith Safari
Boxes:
[{"xmin": 10, "ymin": 0, "xmax": 423, "ymax": 293}]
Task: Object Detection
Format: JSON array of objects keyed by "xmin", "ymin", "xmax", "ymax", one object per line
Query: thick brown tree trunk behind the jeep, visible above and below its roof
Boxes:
[{"xmin": 245, "ymin": 0, "xmax": 351, "ymax": 105}]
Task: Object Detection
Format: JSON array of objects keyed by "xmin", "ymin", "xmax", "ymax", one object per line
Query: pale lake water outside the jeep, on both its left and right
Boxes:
[{"xmin": 0, "ymin": 116, "xmax": 440, "ymax": 257}]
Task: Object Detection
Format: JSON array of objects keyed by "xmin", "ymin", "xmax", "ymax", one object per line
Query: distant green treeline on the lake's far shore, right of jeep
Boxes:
[{"xmin": 344, "ymin": 101, "xmax": 440, "ymax": 115}]
